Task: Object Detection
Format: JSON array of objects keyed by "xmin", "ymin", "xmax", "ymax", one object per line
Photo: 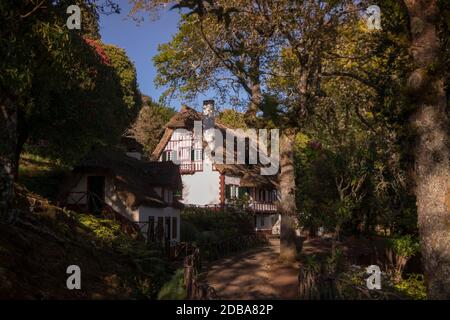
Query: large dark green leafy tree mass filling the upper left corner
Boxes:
[{"xmin": 0, "ymin": 0, "xmax": 139, "ymax": 164}]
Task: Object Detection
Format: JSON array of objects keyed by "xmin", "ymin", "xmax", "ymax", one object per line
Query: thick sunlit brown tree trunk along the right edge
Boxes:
[{"xmin": 405, "ymin": 0, "xmax": 450, "ymax": 299}]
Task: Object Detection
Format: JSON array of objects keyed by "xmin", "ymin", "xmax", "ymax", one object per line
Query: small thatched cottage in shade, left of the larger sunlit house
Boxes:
[{"xmin": 62, "ymin": 147, "xmax": 182, "ymax": 243}]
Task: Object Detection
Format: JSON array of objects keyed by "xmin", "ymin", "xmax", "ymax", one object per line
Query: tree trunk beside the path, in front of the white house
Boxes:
[{"xmin": 279, "ymin": 129, "xmax": 297, "ymax": 261}]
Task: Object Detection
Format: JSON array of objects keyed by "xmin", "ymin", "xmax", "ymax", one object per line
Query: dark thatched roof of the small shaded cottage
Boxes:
[{"xmin": 63, "ymin": 147, "xmax": 182, "ymax": 207}]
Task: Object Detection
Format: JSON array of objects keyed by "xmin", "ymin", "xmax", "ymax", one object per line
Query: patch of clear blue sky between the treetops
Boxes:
[{"xmin": 100, "ymin": 0, "xmax": 180, "ymax": 109}]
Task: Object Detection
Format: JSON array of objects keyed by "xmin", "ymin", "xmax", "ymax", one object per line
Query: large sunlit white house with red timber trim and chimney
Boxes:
[{"xmin": 151, "ymin": 100, "xmax": 280, "ymax": 234}]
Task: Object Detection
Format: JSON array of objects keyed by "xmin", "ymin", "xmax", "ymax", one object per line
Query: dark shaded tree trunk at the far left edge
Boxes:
[{"xmin": 0, "ymin": 98, "xmax": 17, "ymax": 223}]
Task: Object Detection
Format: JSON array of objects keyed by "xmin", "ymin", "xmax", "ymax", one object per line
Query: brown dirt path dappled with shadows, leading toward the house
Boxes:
[{"xmin": 207, "ymin": 239, "xmax": 298, "ymax": 299}]
